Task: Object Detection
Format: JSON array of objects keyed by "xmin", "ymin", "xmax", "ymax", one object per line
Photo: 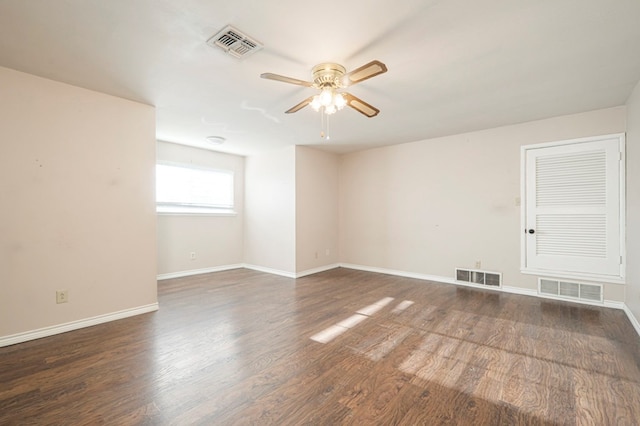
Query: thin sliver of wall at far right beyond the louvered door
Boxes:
[{"xmin": 625, "ymin": 83, "xmax": 640, "ymax": 324}]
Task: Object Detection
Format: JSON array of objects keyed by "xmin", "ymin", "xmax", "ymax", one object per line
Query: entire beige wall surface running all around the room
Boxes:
[{"xmin": 0, "ymin": 64, "xmax": 640, "ymax": 346}]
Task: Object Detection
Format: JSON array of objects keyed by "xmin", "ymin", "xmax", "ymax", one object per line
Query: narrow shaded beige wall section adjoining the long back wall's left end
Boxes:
[{"xmin": 296, "ymin": 146, "xmax": 339, "ymax": 274}]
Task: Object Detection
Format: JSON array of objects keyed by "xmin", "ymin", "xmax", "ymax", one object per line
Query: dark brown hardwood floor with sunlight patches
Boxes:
[{"xmin": 0, "ymin": 269, "xmax": 640, "ymax": 425}]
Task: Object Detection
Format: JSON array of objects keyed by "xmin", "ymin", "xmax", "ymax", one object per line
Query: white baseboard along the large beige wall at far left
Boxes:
[{"xmin": 0, "ymin": 303, "xmax": 158, "ymax": 347}]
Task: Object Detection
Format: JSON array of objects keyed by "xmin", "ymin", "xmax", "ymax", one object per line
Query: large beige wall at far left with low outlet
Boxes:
[{"xmin": 0, "ymin": 68, "xmax": 157, "ymax": 337}]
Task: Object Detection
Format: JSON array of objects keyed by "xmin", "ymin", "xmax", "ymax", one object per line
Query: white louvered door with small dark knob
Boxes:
[{"xmin": 523, "ymin": 135, "xmax": 622, "ymax": 277}]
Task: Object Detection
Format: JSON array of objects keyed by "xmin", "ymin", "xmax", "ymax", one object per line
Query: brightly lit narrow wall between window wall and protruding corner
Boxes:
[{"xmin": 244, "ymin": 146, "xmax": 296, "ymax": 276}]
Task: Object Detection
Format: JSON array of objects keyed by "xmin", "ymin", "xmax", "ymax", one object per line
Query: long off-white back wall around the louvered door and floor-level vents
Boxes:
[{"xmin": 339, "ymin": 107, "xmax": 625, "ymax": 302}]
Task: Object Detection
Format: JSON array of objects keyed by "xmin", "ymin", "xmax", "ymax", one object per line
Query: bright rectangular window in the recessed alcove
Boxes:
[{"xmin": 156, "ymin": 164, "xmax": 235, "ymax": 214}]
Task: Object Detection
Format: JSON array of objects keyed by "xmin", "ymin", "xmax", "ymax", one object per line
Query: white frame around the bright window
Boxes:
[{"xmin": 156, "ymin": 161, "xmax": 237, "ymax": 216}]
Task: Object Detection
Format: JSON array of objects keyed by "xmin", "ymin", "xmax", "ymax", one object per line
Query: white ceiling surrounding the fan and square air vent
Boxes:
[{"xmin": 0, "ymin": 0, "xmax": 640, "ymax": 155}]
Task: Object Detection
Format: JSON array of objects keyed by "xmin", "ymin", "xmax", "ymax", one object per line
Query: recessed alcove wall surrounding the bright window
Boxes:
[{"xmin": 157, "ymin": 142, "xmax": 244, "ymax": 276}]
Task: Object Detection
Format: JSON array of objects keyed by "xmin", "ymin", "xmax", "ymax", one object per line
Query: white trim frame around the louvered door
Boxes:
[{"xmin": 520, "ymin": 133, "xmax": 626, "ymax": 284}]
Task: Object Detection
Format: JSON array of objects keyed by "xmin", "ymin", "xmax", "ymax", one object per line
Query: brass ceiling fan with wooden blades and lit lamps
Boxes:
[{"xmin": 260, "ymin": 61, "xmax": 387, "ymax": 117}]
